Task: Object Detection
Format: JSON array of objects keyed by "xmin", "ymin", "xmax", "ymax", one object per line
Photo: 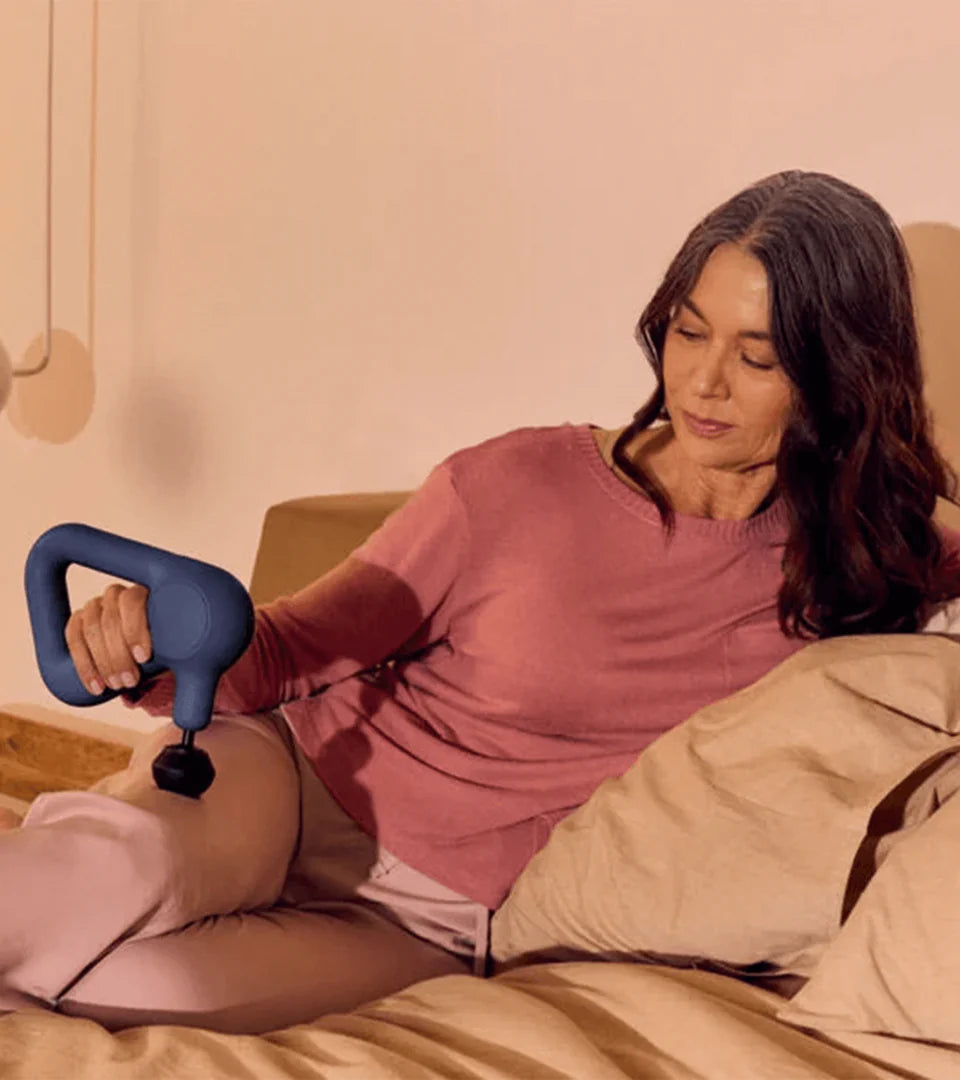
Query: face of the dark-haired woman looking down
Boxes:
[{"xmin": 663, "ymin": 244, "xmax": 792, "ymax": 473}]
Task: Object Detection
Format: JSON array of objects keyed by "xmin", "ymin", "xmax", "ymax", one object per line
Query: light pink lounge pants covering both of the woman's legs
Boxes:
[{"xmin": 0, "ymin": 713, "xmax": 488, "ymax": 1034}]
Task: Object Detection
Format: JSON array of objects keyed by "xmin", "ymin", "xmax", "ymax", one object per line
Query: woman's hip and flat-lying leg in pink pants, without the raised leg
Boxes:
[{"xmin": 48, "ymin": 712, "xmax": 482, "ymax": 1034}]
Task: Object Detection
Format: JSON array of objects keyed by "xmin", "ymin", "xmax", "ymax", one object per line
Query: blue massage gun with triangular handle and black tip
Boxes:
[{"xmin": 25, "ymin": 524, "xmax": 254, "ymax": 798}]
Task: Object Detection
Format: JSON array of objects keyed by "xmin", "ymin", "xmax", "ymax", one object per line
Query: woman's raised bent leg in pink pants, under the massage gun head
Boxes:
[{"xmin": 0, "ymin": 715, "xmax": 299, "ymax": 1002}]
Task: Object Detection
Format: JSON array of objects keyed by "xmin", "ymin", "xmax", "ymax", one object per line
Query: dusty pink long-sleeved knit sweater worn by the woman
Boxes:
[{"xmin": 131, "ymin": 424, "xmax": 825, "ymax": 907}]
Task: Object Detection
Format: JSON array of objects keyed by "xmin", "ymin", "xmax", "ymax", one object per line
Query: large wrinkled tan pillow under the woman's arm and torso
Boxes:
[{"xmin": 491, "ymin": 634, "xmax": 960, "ymax": 976}]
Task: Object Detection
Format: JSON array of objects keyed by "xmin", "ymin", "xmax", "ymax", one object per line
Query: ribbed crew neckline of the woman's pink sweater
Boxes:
[{"xmin": 570, "ymin": 423, "xmax": 787, "ymax": 544}]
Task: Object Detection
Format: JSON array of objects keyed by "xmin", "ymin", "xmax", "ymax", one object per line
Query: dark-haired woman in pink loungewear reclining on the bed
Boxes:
[{"xmin": 0, "ymin": 172, "xmax": 960, "ymax": 1031}]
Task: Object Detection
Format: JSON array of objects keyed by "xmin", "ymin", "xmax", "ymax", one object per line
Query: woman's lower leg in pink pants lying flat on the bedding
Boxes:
[{"xmin": 58, "ymin": 902, "xmax": 470, "ymax": 1035}]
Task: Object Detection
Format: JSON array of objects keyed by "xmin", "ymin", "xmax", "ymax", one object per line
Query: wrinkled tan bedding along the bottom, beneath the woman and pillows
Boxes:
[{"xmin": 0, "ymin": 963, "xmax": 960, "ymax": 1080}]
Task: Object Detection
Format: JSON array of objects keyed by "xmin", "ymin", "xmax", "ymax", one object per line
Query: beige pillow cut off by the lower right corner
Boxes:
[{"xmin": 779, "ymin": 759, "xmax": 960, "ymax": 1044}]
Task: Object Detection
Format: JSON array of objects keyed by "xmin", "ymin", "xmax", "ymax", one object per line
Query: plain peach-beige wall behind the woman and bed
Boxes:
[{"xmin": 0, "ymin": 0, "xmax": 960, "ymax": 728}]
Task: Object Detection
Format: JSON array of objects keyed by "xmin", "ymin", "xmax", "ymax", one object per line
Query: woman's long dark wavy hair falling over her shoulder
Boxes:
[{"xmin": 613, "ymin": 170, "xmax": 960, "ymax": 638}]
